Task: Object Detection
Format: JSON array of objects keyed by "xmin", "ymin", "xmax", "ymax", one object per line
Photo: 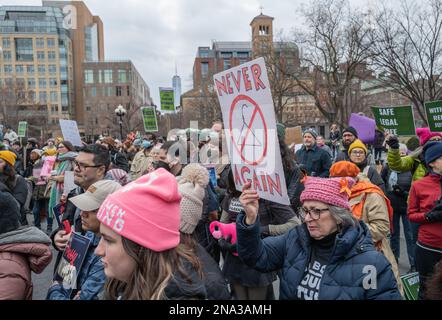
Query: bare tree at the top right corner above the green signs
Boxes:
[{"xmin": 371, "ymin": 0, "xmax": 442, "ymax": 119}]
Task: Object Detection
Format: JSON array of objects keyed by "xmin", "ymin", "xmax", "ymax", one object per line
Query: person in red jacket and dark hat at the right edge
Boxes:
[{"xmin": 408, "ymin": 141, "xmax": 442, "ymax": 299}]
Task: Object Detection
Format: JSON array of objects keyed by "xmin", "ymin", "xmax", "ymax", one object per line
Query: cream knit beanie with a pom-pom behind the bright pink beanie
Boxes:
[{"xmin": 177, "ymin": 163, "xmax": 209, "ymax": 234}]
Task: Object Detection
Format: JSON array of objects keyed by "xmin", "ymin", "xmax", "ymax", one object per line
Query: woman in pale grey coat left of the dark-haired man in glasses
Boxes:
[{"xmin": 47, "ymin": 141, "xmax": 77, "ymax": 234}]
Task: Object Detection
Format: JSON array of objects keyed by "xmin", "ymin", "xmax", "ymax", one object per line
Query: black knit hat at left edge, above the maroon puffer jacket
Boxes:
[{"xmin": 0, "ymin": 191, "xmax": 20, "ymax": 234}]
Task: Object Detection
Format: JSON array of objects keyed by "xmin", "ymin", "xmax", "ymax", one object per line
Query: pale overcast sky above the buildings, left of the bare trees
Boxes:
[{"xmin": 0, "ymin": 0, "xmax": 386, "ymax": 104}]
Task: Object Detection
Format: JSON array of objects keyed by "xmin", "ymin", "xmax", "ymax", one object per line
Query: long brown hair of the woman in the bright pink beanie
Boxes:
[{"xmin": 104, "ymin": 237, "xmax": 202, "ymax": 300}]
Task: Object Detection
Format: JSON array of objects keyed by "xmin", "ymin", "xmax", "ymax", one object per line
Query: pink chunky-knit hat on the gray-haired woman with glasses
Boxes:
[{"xmin": 301, "ymin": 177, "xmax": 355, "ymax": 210}]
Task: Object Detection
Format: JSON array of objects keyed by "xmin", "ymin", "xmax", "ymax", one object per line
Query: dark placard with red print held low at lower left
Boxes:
[{"xmin": 54, "ymin": 232, "xmax": 91, "ymax": 298}]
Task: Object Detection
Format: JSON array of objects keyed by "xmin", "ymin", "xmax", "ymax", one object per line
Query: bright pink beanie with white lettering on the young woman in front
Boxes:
[{"xmin": 97, "ymin": 168, "xmax": 181, "ymax": 252}]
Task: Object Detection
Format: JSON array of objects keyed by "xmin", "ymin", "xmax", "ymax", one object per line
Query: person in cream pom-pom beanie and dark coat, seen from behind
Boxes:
[{"xmin": 178, "ymin": 164, "xmax": 230, "ymax": 300}]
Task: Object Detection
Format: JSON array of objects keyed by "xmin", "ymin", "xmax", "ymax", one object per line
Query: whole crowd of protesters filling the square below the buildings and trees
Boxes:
[{"xmin": 0, "ymin": 122, "xmax": 442, "ymax": 300}]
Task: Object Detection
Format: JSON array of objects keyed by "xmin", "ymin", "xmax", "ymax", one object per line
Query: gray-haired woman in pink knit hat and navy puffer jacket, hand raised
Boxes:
[{"xmin": 237, "ymin": 177, "xmax": 401, "ymax": 300}]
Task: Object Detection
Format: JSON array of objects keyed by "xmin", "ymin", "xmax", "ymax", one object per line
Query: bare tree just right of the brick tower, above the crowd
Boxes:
[{"xmin": 290, "ymin": 0, "xmax": 371, "ymax": 125}]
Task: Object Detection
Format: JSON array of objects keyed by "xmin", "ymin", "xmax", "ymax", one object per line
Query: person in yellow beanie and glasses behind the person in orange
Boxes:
[{"xmin": 348, "ymin": 139, "xmax": 385, "ymax": 192}]
